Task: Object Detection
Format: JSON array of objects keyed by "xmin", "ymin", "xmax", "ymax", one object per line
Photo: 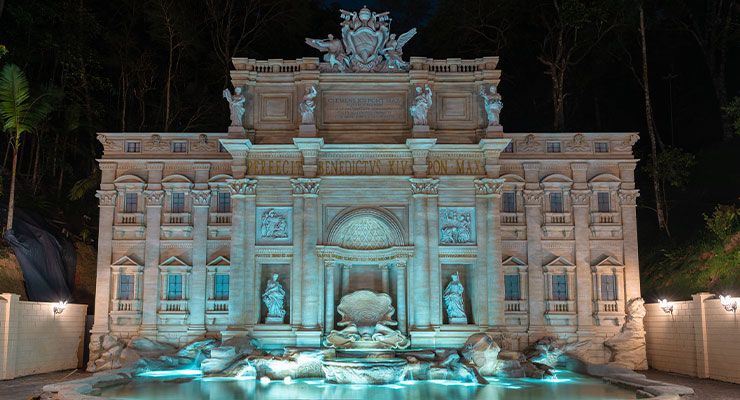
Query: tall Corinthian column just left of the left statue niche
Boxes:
[{"xmin": 226, "ymin": 178, "xmax": 257, "ymax": 331}]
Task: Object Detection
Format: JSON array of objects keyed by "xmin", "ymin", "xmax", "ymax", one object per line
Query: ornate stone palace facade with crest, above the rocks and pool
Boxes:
[{"xmin": 93, "ymin": 3, "xmax": 640, "ymax": 359}]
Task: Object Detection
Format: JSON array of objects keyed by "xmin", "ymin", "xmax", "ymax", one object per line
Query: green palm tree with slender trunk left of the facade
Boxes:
[{"xmin": 0, "ymin": 64, "xmax": 52, "ymax": 230}]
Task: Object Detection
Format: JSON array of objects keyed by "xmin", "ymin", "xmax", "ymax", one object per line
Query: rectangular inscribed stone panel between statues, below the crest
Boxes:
[{"xmin": 322, "ymin": 92, "xmax": 408, "ymax": 124}]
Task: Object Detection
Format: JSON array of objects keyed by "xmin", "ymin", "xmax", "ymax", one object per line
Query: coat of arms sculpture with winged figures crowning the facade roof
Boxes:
[{"xmin": 306, "ymin": 7, "xmax": 416, "ymax": 72}]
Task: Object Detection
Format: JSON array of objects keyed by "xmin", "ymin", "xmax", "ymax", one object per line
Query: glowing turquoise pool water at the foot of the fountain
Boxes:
[{"xmin": 101, "ymin": 371, "xmax": 636, "ymax": 400}]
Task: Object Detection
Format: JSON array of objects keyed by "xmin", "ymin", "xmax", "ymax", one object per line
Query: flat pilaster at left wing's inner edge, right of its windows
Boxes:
[{"xmin": 188, "ymin": 190, "xmax": 211, "ymax": 337}]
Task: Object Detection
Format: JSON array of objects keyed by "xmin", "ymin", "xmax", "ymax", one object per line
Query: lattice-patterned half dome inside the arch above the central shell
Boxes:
[{"xmin": 327, "ymin": 208, "xmax": 404, "ymax": 250}]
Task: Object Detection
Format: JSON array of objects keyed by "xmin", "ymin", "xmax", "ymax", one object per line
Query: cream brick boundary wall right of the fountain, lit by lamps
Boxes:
[{"xmin": 645, "ymin": 293, "xmax": 740, "ymax": 383}]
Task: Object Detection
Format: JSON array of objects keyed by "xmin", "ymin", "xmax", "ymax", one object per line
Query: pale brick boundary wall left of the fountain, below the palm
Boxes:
[{"xmin": 0, "ymin": 293, "xmax": 87, "ymax": 380}]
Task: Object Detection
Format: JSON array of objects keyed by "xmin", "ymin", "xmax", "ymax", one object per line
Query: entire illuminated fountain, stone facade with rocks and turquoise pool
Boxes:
[{"xmin": 43, "ymin": 7, "xmax": 692, "ymax": 400}]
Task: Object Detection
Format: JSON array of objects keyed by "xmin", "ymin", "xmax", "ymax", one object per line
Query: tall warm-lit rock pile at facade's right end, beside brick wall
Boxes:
[{"xmin": 604, "ymin": 297, "xmax": 648, "ymax": 370}]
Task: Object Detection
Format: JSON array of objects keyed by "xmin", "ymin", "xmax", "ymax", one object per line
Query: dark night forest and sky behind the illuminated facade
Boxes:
[{"xmin": 0, "ymin": 0, "xmax": 740, "ymax": 301}]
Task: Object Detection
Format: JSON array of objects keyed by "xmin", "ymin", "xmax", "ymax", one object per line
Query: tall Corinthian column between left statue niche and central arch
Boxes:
[{"xmin": 291, "ymin": 178, "xmax": 321, "ymax": 329}]
